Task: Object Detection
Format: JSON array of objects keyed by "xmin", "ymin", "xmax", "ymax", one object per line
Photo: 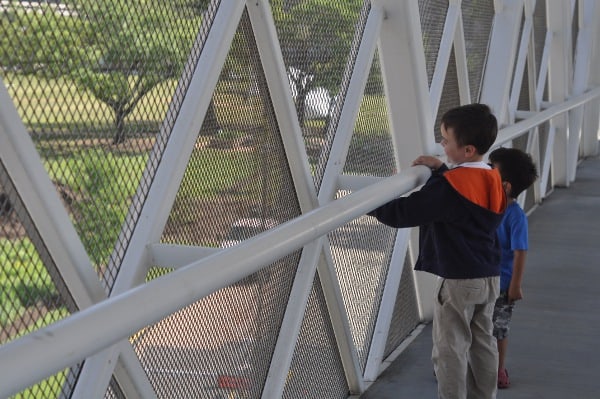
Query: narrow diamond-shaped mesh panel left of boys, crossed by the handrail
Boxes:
[{"xmin": 329, "ymin": 46, "xmax": 408, "ymax": 369}]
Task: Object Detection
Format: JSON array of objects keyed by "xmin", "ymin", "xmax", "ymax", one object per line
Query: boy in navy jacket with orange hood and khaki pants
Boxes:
[{"xmin": 369, "ymin": 104, "xmax": 506, "ymax": 399}]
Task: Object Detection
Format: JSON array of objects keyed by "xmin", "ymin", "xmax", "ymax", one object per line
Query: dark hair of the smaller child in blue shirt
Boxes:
[{"xmin": 488, "ymin": 147, "xmax": 538, "ymax": 198}]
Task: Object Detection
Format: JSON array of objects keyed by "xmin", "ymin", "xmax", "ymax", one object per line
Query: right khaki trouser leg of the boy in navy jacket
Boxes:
[{"xmin": 468, "ymin": 277, "xmax": 499, "ymax": 399}]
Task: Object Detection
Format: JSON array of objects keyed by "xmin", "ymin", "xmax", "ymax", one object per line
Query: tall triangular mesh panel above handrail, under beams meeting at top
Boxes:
[{"xmin": 161, "ymin": 8, "xmax": 300, "ymax": 247}]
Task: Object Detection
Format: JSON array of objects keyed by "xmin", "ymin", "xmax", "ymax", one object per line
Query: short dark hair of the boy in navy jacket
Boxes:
[{"xmin": 441, "ymin": 104, "xmax": 498, "ymax": 155}]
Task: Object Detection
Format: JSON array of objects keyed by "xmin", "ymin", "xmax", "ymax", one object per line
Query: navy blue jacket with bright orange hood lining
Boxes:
[{"xmin": 369, "ymin": 165, "xmax": 506, "ymax": 279}]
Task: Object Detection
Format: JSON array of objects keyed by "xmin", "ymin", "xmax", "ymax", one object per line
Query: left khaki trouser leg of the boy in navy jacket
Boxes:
[{"xmin": 431, "ymin": 279, "xmax": 478, "ymax": 399}]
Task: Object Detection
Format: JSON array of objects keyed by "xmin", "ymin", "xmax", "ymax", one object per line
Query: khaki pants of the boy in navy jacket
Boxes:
[{"xmin": 431, "ymin": 277, "xmax": 500, "ymax": 399}]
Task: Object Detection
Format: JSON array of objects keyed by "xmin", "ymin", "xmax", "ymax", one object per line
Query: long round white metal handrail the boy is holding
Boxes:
[{"xmin": 0, "ymin": 87, "xmax": 600, "ymax": 397}]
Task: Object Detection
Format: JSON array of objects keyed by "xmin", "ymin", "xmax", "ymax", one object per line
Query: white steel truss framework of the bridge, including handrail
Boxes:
[{"xmin": 0, "ymin": 0, "xmax": 600, "ymax": 398}]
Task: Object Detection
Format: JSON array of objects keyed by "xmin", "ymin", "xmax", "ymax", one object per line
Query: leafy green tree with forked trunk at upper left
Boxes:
[{"xmin": 0, "ymin": 0, "xmax": 209, "ymax": 143}]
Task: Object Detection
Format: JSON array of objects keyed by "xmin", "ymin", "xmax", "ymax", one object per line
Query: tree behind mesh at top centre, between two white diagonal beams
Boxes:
[{"xmin": 272, "ymin": 0, "xmax": 363, "ymax": 125}]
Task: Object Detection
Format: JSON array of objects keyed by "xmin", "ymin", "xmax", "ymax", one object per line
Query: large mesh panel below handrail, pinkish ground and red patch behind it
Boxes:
[{"xmin": 138, "ymin": 255, "xmax": 299, "ymax": 399}]
